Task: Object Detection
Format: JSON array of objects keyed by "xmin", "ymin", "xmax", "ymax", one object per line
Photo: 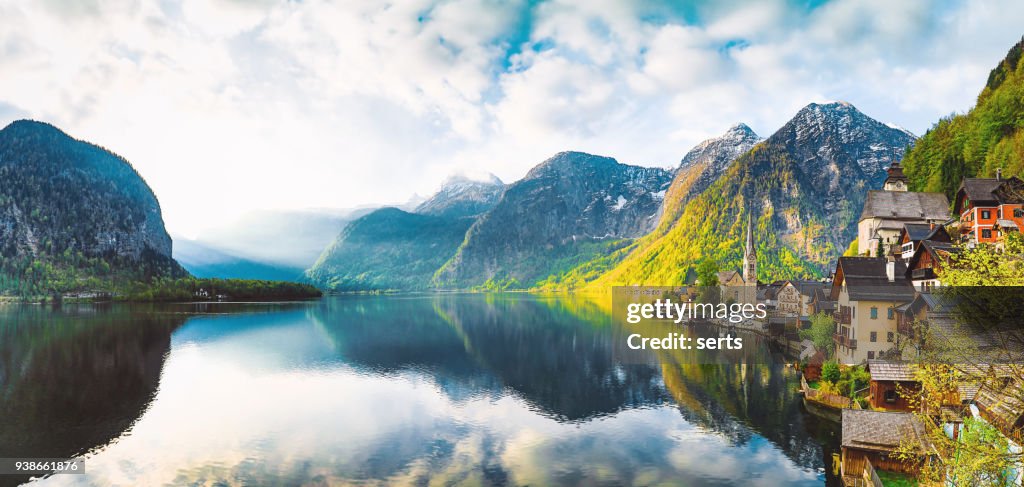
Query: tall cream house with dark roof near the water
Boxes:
[{"xmin": 831, "ymin": 257, "xmax": 914, "ymax": 364}]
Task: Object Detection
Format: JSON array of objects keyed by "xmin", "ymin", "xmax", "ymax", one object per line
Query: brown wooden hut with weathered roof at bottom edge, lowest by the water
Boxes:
[{"xmin": 840, "ymin": 409, "xmax": 931, "ymax": 485}]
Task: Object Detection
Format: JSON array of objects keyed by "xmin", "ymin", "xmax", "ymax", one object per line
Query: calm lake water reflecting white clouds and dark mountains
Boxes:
[{"xmin": 0, "ymin": 295, "xmax": 839, "ymax": 486}]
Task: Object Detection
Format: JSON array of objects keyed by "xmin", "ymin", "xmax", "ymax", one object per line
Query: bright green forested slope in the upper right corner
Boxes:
[{"xmin": 903, "ymin": 35, "xmax": 1024, "ymax": 201}]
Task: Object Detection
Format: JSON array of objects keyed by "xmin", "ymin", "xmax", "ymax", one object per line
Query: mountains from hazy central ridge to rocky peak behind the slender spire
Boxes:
[{"xmin": 307, "ymin": 102, "xmax": 914, "ymax": 291}]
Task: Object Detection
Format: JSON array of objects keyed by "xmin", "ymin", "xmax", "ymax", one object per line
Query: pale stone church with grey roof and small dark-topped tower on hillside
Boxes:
[{"xmin": 857, "ymin": 163, "xmax": 949, "ymax": 257}]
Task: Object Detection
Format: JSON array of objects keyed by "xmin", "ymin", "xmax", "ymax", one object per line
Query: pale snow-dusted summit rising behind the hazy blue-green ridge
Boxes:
[{"xmin": 414, "ymin": 174, "xmax": 505, "ymax": 218}]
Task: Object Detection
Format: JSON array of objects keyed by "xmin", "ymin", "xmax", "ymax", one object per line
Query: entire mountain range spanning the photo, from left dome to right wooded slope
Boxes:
[{"xmin": 9, "ymin": 36, "xmax": 1024, "ymax": 293}]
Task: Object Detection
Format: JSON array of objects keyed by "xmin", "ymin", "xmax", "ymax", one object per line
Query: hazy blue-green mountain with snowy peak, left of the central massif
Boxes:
[{"xmin": 306, "ymin": 176, "xmax": 505, "ymax": 291}]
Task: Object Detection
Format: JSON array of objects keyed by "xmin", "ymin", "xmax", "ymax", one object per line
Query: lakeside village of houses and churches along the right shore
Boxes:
[{"xmin": 718, "ymin": 163, "xmax": 1024, "ymax": 486}]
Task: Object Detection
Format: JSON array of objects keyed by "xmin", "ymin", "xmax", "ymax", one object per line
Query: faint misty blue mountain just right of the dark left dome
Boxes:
[{"xmin": 174, "ymin": 238, "xmax": 303, "ymax": 281}]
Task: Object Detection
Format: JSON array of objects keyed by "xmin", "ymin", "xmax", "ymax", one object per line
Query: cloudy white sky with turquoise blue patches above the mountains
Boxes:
[{"xmin": 0, "ymin": 0, "xmax": 1024, "ymax": 236}]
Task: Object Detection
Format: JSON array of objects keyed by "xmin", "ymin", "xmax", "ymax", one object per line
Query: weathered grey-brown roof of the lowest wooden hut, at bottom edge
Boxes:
[{"xmin": 843, "ymin": 409, "xmax": 928, "ymax": 452}]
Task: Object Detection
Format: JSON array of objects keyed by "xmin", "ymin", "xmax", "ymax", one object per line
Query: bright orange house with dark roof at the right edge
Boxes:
[{"xmin": 953, "ymin": 171, "xmax": 1024, "ymax": 245}]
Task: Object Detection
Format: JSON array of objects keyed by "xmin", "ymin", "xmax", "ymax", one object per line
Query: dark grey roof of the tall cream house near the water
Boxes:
[{"xmin": 834, "ymin": 257, "xmax": 914, "ymax": 303}]
